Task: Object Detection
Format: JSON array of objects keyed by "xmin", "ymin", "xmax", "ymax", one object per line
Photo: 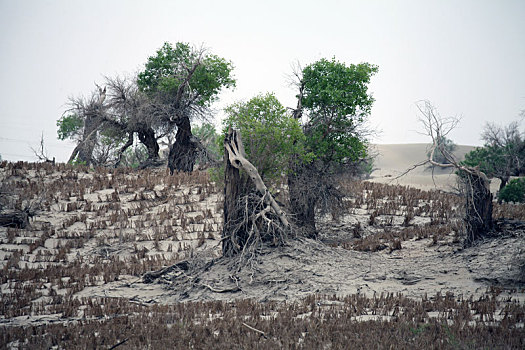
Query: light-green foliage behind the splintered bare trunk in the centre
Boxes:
[{"xmin": 219, "ymin": 93, "xmax": 308, "ymax": 180}]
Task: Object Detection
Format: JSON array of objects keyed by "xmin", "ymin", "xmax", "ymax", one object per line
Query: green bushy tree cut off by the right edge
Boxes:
[{"xmin": 462, "ymin": 122, "xmax": 525, "ymax": 191}]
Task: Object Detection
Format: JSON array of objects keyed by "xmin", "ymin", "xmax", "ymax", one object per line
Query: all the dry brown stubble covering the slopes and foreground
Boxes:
[{"xmin": 0, "ymin": 150, "xmax": 525, "ymax": 349}]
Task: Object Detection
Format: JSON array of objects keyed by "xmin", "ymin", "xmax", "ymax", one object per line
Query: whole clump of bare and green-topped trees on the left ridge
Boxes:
[{"xmin": 57, "ymin": 43, "xmax": 235, "ymax": 171}]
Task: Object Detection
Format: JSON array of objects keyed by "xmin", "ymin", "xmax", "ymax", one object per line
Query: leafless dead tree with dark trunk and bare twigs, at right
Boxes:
[{"xmin": 410, "ymin": 101, "xmax": 493, "ymax": 245}]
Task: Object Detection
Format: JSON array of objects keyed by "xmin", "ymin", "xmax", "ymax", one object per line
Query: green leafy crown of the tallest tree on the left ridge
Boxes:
[{"xmin": 137, "ymin": 42, "xmax": 235, "ymax": 107}]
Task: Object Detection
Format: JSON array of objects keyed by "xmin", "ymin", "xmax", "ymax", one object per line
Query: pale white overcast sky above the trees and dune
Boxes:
[{"xmin": 0, "ymin": 0, "xmax": 525, "ymax": 161}]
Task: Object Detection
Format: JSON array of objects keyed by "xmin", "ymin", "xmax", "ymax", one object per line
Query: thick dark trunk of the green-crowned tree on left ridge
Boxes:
[{"xmin": 168, "ymin": 118, "xmax": 196, "ymax": 174}]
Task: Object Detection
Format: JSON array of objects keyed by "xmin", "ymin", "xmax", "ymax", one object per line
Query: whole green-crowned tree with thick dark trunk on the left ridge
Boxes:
[{"xmin": 137, "ymin": 43, "xmax": 235, "ymax": 172}]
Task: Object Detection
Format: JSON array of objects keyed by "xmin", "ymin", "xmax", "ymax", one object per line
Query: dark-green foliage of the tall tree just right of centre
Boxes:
[{"xmin": 301, "ymin": 59, "xmax": 377, "ymax": 163}]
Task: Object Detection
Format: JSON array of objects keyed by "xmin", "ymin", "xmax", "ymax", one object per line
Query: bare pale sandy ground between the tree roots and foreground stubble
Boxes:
[{"xmin": 139, "ymin": 219, "xmax": 525, "ymax": 302}]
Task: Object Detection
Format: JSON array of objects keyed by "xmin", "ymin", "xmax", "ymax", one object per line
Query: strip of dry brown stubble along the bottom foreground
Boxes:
[{"xmin": 0, "ymin": 294, "xmax": 525, "ymax": 349}]
